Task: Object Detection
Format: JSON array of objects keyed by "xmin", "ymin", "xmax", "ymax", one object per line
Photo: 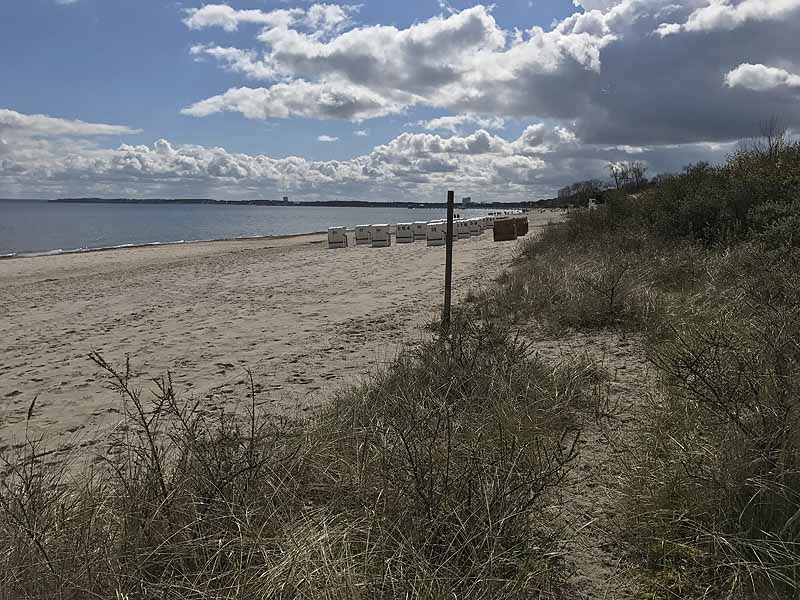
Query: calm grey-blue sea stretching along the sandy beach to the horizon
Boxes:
[{"xmin": 0, "ymin": 200, "xmax": 485, "ymax": 258}]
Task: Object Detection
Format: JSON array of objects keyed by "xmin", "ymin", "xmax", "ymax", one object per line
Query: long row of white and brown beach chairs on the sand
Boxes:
[{"xmin": 328, "ymin": 213, "xmax": 528, "ymax": 249}]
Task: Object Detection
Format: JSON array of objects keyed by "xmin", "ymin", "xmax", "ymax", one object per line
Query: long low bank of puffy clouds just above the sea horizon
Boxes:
[{"xmin": 0, "ymin": 108, "xmax": 685, "ymax": 201}]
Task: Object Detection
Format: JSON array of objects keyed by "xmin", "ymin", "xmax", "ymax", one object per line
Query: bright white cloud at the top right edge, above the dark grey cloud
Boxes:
[{"xmin": 657, "ymin": 0, "xmax": 800, "ymax": 37}]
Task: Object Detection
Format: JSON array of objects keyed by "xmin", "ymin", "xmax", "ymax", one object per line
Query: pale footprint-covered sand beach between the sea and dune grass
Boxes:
[{"xmin": 0, "ymin": 212, "xmax": 558, "ymax": 448}]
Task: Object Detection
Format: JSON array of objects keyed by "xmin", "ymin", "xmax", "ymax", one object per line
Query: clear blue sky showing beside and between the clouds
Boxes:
[{"xmin": 0, "ymin": 0, "xmax": 575, "ymax": 159}]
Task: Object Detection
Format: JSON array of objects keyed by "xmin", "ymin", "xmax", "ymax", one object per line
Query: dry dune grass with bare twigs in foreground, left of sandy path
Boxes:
[{"xmin": 0, "ymin": 312, "xmax": 589, "ymax": 599}]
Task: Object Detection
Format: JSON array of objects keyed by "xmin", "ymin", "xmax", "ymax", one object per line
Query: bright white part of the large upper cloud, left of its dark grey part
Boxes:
[{"xmin": 186, "ymin": 5, "xmax": 615, "ymax": 120}]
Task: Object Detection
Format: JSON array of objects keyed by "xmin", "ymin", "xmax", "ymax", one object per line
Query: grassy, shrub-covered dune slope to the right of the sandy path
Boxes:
[{"xmin": 491, "ymin": 131, "xmax": 800, "ymax": 598}]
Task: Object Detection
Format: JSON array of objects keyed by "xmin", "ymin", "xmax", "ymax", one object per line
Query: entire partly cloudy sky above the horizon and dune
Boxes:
[{"xmin": 0, "ymin": 0, "xmax": 800, "ymax": 202}]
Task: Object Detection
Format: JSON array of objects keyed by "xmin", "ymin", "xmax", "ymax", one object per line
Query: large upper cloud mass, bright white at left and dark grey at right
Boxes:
[{"xmin": 184, "ymin": 0, "xmax": 800, "ymax": 147}]
